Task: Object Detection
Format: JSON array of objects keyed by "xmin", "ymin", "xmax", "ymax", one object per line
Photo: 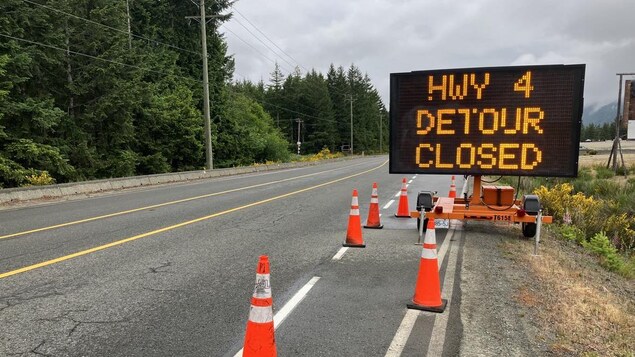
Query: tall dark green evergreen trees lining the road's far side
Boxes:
[{"xmin": 0, "ymin": 0, "xmax": 388, "ymax": 187}]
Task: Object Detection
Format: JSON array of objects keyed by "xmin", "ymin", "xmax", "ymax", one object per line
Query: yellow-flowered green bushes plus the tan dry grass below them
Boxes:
[{"xmin": 501, "ymin": 165, "xmax": 635, "ymax": 357}]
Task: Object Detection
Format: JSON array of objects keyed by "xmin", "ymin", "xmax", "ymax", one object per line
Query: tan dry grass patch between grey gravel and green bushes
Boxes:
[{"xmin": 500, "ymin": 227, "xmax": 635, "ymax": 356}]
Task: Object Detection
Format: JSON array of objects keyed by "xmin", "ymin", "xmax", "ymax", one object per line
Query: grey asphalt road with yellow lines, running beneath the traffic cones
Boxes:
[{"xmin": 0, "ymin": 157, "xmax": 464, "ymax": 356}]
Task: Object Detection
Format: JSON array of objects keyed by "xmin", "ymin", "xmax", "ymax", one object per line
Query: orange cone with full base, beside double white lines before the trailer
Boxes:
[{"xmin": 407, "ymin": 218, "xmax": 448, "ymax": 312}]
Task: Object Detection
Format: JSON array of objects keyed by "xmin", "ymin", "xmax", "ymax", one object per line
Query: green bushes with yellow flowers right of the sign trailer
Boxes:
[{"xmin": 508, "ymin": 165, "xmax": 635, "ymax": 279}]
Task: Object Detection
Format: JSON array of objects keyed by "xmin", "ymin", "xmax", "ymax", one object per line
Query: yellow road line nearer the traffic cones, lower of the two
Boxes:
[{"xmin": 0, "ymin": 160, "xmax": 388, "ymax": 279}]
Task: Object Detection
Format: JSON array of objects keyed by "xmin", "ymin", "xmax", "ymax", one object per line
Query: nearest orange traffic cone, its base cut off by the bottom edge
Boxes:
[{"xmin": 243, "ymin": 255, "xmax": 276, "ymax": 357}]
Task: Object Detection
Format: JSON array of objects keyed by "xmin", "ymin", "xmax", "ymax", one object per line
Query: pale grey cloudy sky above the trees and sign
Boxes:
[{"xmin": 221, "ymin": 0, "xmax": 635, "ymax": 110}]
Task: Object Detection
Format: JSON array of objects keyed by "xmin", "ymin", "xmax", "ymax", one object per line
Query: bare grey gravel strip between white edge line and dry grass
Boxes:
[{"xmin": 461, "ymin": 222, "xmax": 551, "ymax": 356}]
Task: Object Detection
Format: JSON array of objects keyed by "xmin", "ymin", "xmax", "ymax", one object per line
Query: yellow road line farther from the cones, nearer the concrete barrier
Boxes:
[{"xmin": 0, "ymin": 161, "xmax": 370, "ymax": 240}]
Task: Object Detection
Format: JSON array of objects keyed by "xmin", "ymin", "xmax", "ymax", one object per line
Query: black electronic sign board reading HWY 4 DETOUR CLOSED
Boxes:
[{"xmin": 390, "ymin": 64, "xmax": 585, "ymax": 177}]
